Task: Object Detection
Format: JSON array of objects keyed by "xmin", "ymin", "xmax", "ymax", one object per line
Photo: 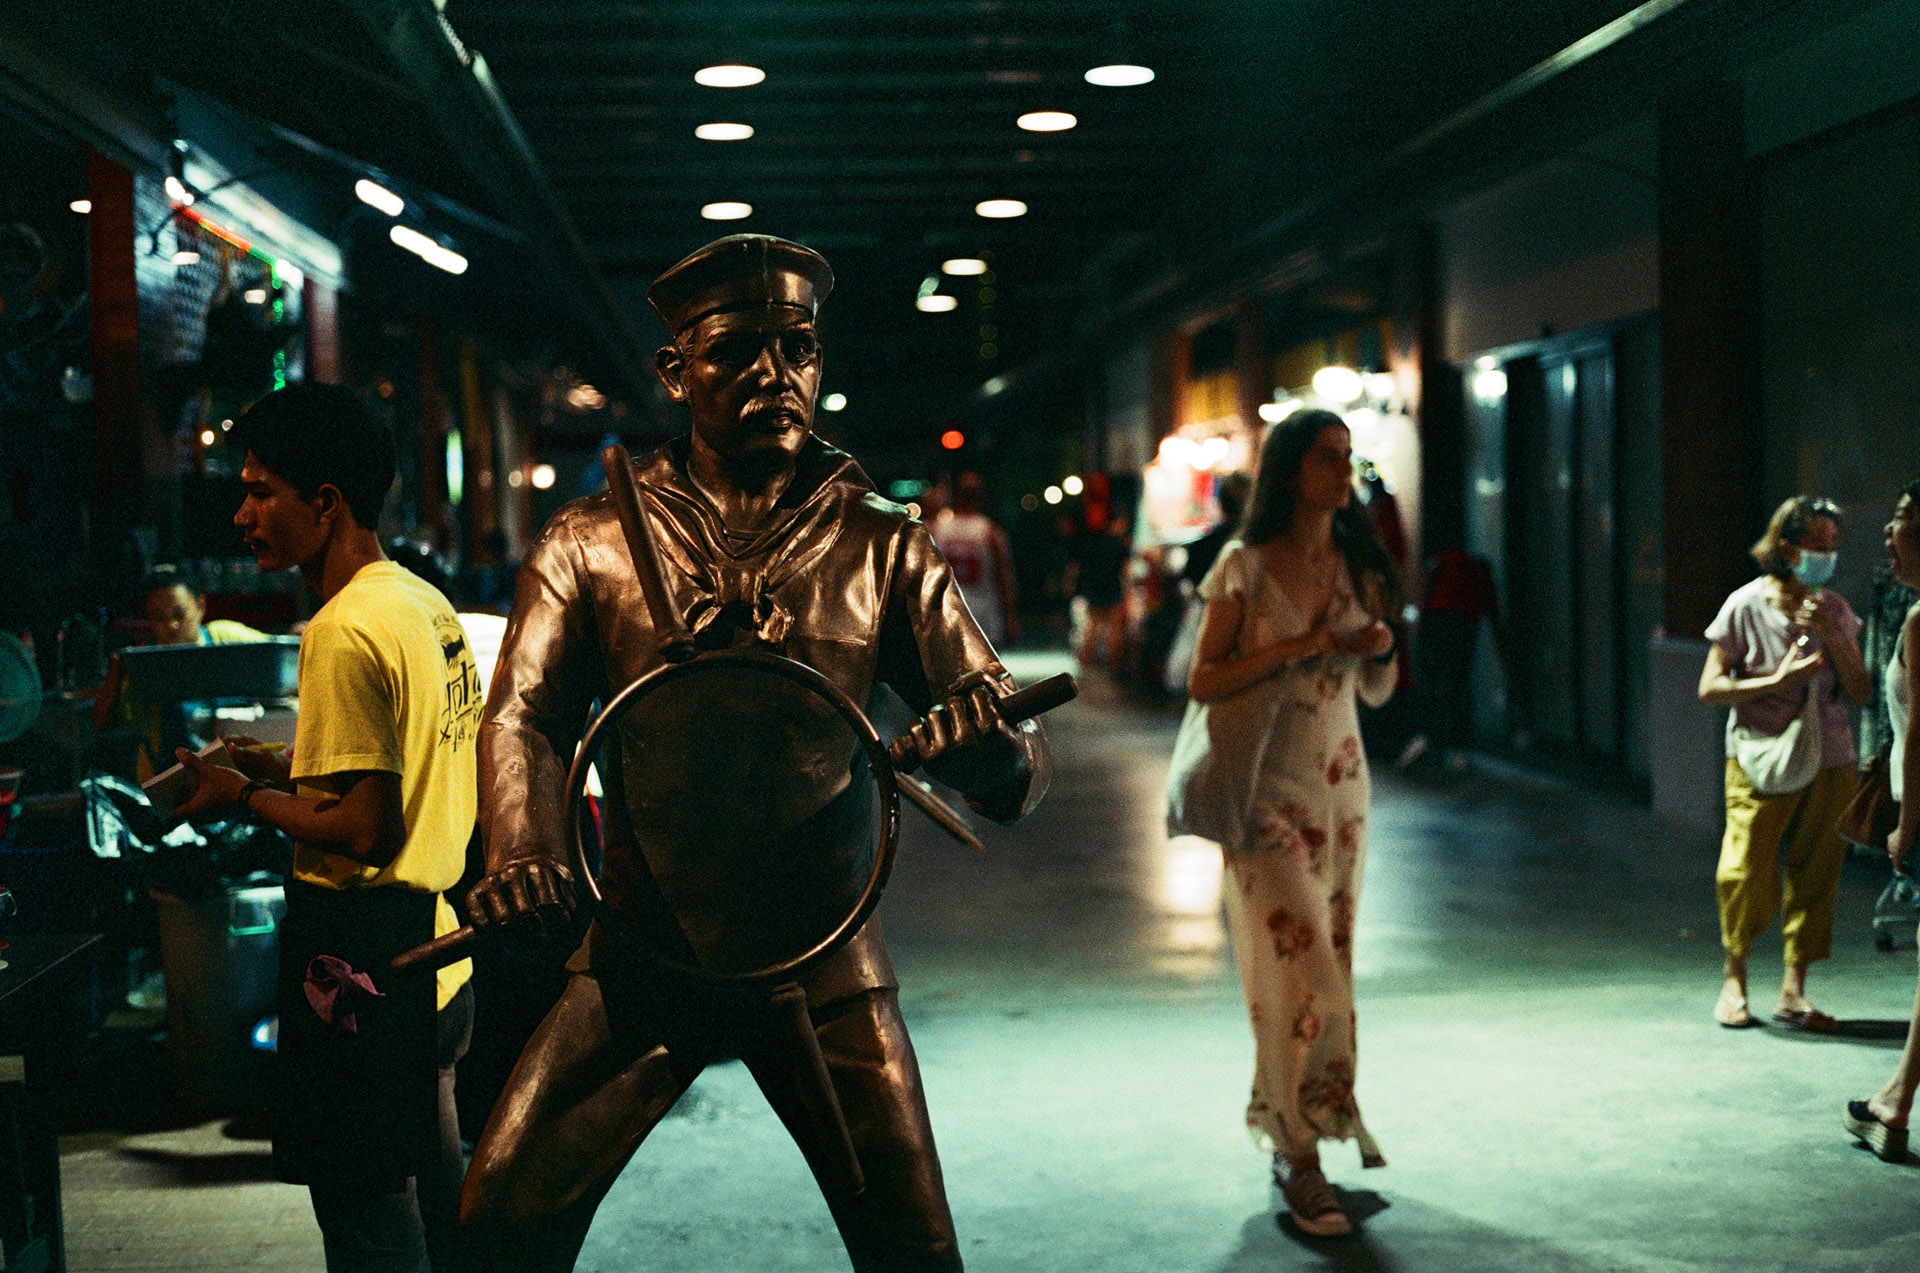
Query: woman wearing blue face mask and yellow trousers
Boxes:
[{"xmin": 1699, "ymin": 495, "xmax": 1872, "ymax": 1031}]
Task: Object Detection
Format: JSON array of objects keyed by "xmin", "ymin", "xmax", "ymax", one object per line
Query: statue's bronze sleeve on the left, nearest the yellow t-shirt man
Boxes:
[{"xmin": 480, "ymin": 511, "xmax": 603, "ymax": 870}]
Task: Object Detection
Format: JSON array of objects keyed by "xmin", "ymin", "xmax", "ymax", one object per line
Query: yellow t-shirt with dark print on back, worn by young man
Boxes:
[{"xmin": 294, "ymin": 561, "xmax": 486, "ymax": 1008}]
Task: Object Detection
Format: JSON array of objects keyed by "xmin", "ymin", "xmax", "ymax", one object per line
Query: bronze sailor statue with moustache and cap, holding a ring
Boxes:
[{"xmin": 461, "ymin": 234, "xmax": 1069, "ymax": 1273}]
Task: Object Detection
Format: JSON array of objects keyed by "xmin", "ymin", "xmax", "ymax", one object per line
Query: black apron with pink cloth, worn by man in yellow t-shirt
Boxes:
[{"xmin": 273, "ymin": 879, "xmax": 440, "ymax": 1190}]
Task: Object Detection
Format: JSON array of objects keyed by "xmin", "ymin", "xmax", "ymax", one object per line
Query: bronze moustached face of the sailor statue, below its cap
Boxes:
[{"xmin": 655, "ymin": 305, "xmax": 820, "ymax": 463}]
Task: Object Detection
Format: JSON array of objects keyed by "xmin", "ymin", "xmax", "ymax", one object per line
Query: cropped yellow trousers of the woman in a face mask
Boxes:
[{"xmin": 1713, "ymin": 757, "xmax": 1860, "ymax": 964}]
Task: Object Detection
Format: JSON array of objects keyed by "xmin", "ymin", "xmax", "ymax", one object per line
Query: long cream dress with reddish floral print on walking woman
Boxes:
[{"xmin": 1200, "ymin": 541, "xmax": 1396, "ymax": 1165}]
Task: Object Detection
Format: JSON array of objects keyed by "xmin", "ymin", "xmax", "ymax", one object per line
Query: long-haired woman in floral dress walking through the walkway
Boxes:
[{"xmin": 1169, "ymin": 411, "xmax": 1398, "ymax": 1237}]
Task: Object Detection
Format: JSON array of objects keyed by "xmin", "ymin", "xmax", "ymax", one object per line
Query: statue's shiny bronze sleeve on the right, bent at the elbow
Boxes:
[{"xmin": 877, "ymin": 522, "xmax": 1052, "ymax": 822}]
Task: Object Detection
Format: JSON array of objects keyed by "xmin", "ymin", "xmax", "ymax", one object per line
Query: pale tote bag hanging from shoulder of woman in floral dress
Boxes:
[{"xmin": 1167, "ymin": 549, "xmax": 1286, "ymax": 849}]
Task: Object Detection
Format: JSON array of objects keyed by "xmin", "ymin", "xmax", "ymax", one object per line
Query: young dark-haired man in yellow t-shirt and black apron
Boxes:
[{"xmin": 179, "ymin": 384, "xmax": 484, "ymax": 1273}]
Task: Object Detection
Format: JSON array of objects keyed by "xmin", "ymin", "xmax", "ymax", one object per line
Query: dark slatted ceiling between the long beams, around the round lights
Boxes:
[{"xmin": 447, "ymin": 0, "xmax": 1632, "ymax": 397}]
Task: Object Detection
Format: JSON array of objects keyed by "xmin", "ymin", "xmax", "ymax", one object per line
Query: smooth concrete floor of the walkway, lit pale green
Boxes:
[{"xmin": 52, "ymin": 662, "xmax": 1920, "ymax": 1273}]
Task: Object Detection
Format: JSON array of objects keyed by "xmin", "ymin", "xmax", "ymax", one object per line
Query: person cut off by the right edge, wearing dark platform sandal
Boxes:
[{"xmin": 1845, "ymin": 478, "xmax": 1920, "ymax": 1162}]
